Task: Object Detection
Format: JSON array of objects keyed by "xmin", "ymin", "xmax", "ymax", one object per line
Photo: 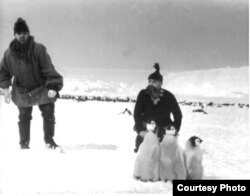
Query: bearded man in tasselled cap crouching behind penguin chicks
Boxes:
[{"xmin": 134, "ymin": 63, "xmax": 182, "ymax": 152}]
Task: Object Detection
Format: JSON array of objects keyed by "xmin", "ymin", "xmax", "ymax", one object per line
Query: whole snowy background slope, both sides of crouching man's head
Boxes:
[{"xmin": 62, "ymin": 66, "xmax": 249, "ymax": 99}]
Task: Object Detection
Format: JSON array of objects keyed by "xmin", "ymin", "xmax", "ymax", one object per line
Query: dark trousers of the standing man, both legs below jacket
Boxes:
[{"xmin": 18, "ymin": 103, "xmax": 55, "ymax": 144}]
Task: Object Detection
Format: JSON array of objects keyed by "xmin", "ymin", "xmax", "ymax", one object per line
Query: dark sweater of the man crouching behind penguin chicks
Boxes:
[{"xmin": 134, "ymin": 89, "xmax": 182, "ymax": 133}]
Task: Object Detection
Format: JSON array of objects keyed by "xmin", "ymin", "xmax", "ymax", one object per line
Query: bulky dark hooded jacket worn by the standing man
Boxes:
[{"xmin": 0, "ymin": 36, "xmax": 63, "ymax": 107}]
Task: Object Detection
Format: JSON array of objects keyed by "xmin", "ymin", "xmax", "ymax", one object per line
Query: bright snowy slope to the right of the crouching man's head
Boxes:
[{"xmin": 165, "ymin": 67, "xmax": 249, "ymax": 98}]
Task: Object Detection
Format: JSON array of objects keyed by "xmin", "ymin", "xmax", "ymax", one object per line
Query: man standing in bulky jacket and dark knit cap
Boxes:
[{"xmin": 0, "ymin": 18, "xmax": 63, "ymax": 149}]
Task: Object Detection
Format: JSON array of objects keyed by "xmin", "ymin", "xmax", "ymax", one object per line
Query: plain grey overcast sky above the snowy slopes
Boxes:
[{"xmin": 0, "ymin": 0, "xmax": 248, "ymax": 72}]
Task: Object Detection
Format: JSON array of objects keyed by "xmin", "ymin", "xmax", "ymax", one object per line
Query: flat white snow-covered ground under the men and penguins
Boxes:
[{"xmin": 0, "ymin": 96, "xmax": 250, "ymax": 196}]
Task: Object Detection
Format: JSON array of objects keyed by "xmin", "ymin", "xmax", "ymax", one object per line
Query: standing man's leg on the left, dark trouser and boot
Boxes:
[{"xmin": 18, "ymin": 107, "xmax": 32, "ymax": 149}]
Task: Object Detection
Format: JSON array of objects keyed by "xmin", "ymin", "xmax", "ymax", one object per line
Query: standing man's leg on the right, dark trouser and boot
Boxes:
[{"xmin": 39, "ymin": 103, "xmax": 58, "ymax": 148}]
